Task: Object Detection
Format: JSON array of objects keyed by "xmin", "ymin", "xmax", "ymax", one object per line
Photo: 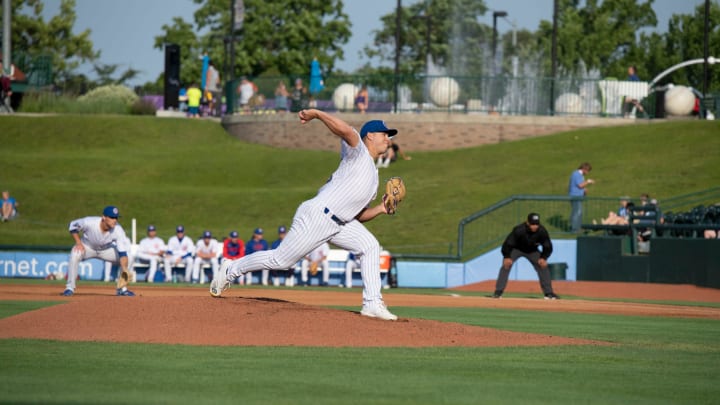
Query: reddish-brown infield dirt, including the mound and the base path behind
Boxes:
[{"xmin": 0, "ymin": 281, "xmax": 720, "ymax": 347}]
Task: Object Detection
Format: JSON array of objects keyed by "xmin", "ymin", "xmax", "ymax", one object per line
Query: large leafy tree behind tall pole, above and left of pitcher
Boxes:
[{"xmin": 155, "ymin": 0, "xmax": 351, "ymax": 82}]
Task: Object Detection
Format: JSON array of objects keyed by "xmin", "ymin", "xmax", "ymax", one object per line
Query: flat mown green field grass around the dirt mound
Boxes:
[{"xmin": 0, "ymin": 302, "xmax": 720, "ymax": 404}]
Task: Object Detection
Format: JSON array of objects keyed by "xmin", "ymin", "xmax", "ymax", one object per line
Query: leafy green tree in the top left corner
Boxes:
[{"xmin": 0, "ymin": 0, "xmax": 100, "ymax": 82}]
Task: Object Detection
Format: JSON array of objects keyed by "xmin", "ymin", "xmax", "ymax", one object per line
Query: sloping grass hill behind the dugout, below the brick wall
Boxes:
[{"xmin": 0, "ymin": 115, "xmax": 720, "ymax": 254}]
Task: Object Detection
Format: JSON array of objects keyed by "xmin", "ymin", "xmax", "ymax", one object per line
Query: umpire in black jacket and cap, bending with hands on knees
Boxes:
[{"xmin": 493, "ymin": 212, "xmax": 560, "ymax": 300}]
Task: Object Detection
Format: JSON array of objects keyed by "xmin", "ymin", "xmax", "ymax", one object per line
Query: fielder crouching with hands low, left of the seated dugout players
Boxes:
[{"xmin": 62, "ymin": 205, "xmax": 135, "ymax": 297}]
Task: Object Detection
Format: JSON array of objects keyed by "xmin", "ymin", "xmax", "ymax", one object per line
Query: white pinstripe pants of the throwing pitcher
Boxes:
[{"xmin": 228, "ymin": 199, "xmax": 382, "ymax": 304}]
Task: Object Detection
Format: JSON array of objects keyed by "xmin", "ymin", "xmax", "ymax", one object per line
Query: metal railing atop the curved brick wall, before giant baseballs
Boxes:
[{"xmin": 225, "ymin": 75, "xmax": 720, "ymax": 118}]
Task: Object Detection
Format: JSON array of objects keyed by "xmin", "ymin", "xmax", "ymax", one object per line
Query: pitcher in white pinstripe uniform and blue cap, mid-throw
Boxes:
[{"xmin": 210, "ymin": 109, "xmax": 397, "ymax": 321}]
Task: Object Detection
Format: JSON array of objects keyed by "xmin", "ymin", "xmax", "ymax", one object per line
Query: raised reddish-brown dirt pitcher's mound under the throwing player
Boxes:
[{"xmin": 0, "ymin": 296, "xmax": 604, "ymax": 347}]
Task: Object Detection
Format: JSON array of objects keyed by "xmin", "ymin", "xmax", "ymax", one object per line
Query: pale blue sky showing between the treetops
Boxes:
[{"xmin": 36, "ymin": 0, "xmax": 704, "ymax": 85}]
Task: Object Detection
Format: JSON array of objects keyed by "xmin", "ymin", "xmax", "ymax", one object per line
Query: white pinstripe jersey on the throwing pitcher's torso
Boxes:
[{"xmin": 317, "ymin": 128, "xmax": 378, "ymax": 222}]
